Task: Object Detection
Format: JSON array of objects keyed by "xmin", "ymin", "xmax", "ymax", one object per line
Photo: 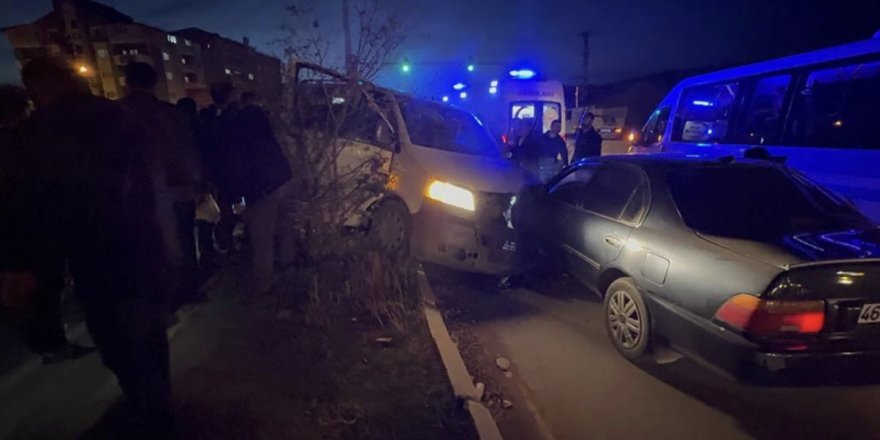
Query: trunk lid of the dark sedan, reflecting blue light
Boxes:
[{"xmin": 700, "ymin": 227, "xmax": 880, "ymax": 268}]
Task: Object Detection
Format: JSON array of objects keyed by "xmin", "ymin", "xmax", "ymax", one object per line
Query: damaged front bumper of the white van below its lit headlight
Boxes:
[{"xmin": 412, "ymin": 196, "xmax": 517, "ymax": 276}]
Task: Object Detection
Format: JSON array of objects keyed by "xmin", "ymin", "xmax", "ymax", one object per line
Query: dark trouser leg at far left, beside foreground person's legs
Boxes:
[{"xmin": 18, "ymin": 258, "xmax": 67, "ymax": 354}]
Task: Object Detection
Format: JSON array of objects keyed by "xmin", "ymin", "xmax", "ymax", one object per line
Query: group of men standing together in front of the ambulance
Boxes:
[{"xmin": 508, "ymin": 112, "xmax": 602, "ymax": 182}]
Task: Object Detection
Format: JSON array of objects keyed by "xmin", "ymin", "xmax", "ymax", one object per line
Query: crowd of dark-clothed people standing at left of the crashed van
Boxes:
[{"xmin": 0, "ymin": 58, "xmax": 291, "ymax": 438}]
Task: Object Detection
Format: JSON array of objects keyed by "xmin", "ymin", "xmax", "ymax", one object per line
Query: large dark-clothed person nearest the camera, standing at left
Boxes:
[{"xmin": 16, "ymin": 59, "xmax": 173, "ymax": 438}]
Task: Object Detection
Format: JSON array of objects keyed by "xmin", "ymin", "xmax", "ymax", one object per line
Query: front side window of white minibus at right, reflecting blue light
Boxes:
[{"xmin": 672, "ymin": 82, "xmax": 740, "ymax": 142}]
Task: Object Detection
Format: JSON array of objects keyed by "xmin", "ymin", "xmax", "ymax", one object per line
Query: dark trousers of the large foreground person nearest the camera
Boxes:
[{"xmin": 72, "ymin": 259, "xmax": 172, "ymax": 430}]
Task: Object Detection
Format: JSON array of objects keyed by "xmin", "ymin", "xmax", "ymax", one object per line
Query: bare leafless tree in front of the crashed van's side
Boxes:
[{"xmin": 277, "ymin": 0, "xmax": 406, "ymax": 272}]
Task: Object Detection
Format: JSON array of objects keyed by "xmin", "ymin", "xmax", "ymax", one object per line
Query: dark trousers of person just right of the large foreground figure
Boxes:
[{"xmin": 172, "ymin": 200, "xmax": 202, "ymax": 305}]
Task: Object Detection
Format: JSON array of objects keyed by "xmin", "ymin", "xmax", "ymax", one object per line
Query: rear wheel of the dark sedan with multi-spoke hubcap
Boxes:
[{"xmin": 605, "ymin": 278, "xmax": 651, "ymax": 362}]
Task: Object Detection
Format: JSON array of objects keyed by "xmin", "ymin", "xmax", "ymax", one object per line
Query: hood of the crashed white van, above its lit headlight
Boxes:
[{"xmin": 411, "ymin": 145, "xmax": 526, "ymax": 194}]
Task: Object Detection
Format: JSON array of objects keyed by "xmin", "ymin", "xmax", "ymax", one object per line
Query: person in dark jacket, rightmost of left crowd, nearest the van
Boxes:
[{"xmin": 212, "ymin": 86, "xmax": 292, "ymax": 301}]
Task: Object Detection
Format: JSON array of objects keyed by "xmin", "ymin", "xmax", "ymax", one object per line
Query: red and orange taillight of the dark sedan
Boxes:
[{"xmin": 715, "ymin": 293, "xmax": 825, "ymax": 336}]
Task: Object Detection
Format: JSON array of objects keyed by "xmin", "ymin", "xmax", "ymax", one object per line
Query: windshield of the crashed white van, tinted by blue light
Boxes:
[{"xmin": 400, "ymin": 98, "xmax": 501, "ymax": 158}]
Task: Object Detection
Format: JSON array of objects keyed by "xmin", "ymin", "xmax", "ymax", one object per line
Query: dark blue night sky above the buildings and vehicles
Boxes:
[{"xmin": 0, "ymin": 0, "xmax": 880, "ymax": 86}]
